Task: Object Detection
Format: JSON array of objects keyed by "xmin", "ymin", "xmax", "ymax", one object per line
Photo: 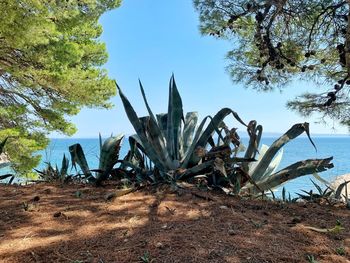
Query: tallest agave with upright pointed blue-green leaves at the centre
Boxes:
[{"xmin": 116, "ymin": 76, "xmax": 247, "ymax": 182}]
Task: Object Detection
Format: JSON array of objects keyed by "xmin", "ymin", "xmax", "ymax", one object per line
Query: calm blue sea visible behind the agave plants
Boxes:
[{"xmin": 30, "ymin": 137, "xmax": 350, "ymax": 195}]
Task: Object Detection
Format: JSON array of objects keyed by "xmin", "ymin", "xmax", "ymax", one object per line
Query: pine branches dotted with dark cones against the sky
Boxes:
[{"xmin": 193, "ymin": 0, "xmax": 350, "ymax": 131}]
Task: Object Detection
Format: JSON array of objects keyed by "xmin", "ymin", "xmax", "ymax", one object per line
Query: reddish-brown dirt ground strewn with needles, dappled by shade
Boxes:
[{"xmin": 0, "ymin": 183, "xmax": 350, "ymax": 263}]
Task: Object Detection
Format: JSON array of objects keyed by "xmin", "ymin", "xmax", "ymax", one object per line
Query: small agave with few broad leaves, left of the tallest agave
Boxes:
[{"xmin": 69, "ymin": 135, "xmax": 124, "ymax": 184}]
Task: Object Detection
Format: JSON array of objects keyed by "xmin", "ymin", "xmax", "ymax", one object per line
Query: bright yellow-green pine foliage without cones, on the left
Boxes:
[{"xmin": 0, "ymin": 0, "xmax": 120, "ymax": 174}]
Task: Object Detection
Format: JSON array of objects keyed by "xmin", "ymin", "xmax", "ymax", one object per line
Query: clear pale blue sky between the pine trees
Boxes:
[{"xmin": 60, "ymin": 0, "xmax": 347, "ymax": 138}]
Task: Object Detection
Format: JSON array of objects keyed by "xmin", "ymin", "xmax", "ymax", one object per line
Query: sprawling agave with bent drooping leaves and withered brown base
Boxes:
[{"xmin": 180, "ymin": 121, "xmax": 333, "ymax": 194}]
